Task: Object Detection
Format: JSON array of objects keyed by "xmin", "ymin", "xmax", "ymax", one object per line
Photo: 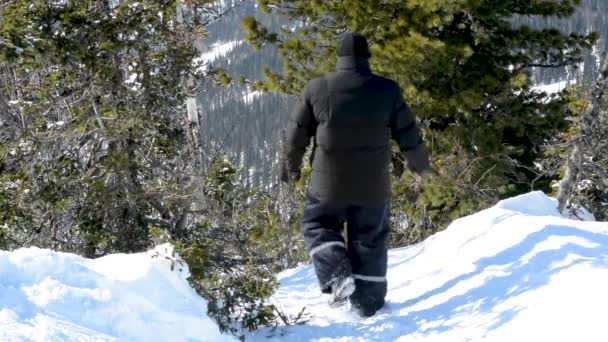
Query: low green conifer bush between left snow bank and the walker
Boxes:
[{"xmin": 169, "ymin": 158, "xmax": 306, "ymax": 334}]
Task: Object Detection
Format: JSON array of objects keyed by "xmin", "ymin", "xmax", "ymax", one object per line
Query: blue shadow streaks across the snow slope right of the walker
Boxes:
[{"xmin": 266, "ymin": 225, "xmax": 608, "ymax": 341}]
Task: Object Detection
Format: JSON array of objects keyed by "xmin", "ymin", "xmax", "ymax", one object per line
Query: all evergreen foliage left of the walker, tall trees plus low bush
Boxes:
[{"xmin": 0, "ymin": 0, "xmax": 294, "ymax": 332}]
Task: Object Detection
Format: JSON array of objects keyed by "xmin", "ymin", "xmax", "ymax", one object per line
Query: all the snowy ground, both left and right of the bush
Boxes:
[{"xmin": 0, "ymin": 192, "xmax": 608, "ymax": 342}]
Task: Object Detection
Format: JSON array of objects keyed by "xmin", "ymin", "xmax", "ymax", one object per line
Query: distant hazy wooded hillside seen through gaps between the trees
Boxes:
[{"xmin": 199, "ymin": 0, "xmax": 608, "ymax": 185}]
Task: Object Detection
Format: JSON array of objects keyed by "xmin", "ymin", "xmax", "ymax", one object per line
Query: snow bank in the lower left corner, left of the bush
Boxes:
[{"xmin": 0, "ymin": 245, "xmax": 232, "ymax": 341}]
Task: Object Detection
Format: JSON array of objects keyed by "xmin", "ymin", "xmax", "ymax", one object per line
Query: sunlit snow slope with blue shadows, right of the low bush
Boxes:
[{"xmin": 249, "ymin": 192, "xmax": 608, "ymax": 342}]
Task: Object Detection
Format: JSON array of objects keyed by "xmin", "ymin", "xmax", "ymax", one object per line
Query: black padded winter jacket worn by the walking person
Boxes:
[{"xmin": 282, "ymin": 56, "xmax": 429, "ymax": 206}]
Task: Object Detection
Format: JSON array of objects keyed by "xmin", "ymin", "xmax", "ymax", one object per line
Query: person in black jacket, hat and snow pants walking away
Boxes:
[{"xmin": 282, "ymin": 33, "xmax": 429, "ymax": 317}]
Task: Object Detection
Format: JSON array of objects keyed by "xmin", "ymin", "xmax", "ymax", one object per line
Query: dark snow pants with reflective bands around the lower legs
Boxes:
[{"xmin": 302, "ymin": 195, "xmax": 390, "ymax": 310}]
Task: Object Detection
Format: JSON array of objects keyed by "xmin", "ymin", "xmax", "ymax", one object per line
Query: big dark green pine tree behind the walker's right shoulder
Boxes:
[{"xmin": 243, "ymin": 0, "xmax": 598, "ymax": 245}]
